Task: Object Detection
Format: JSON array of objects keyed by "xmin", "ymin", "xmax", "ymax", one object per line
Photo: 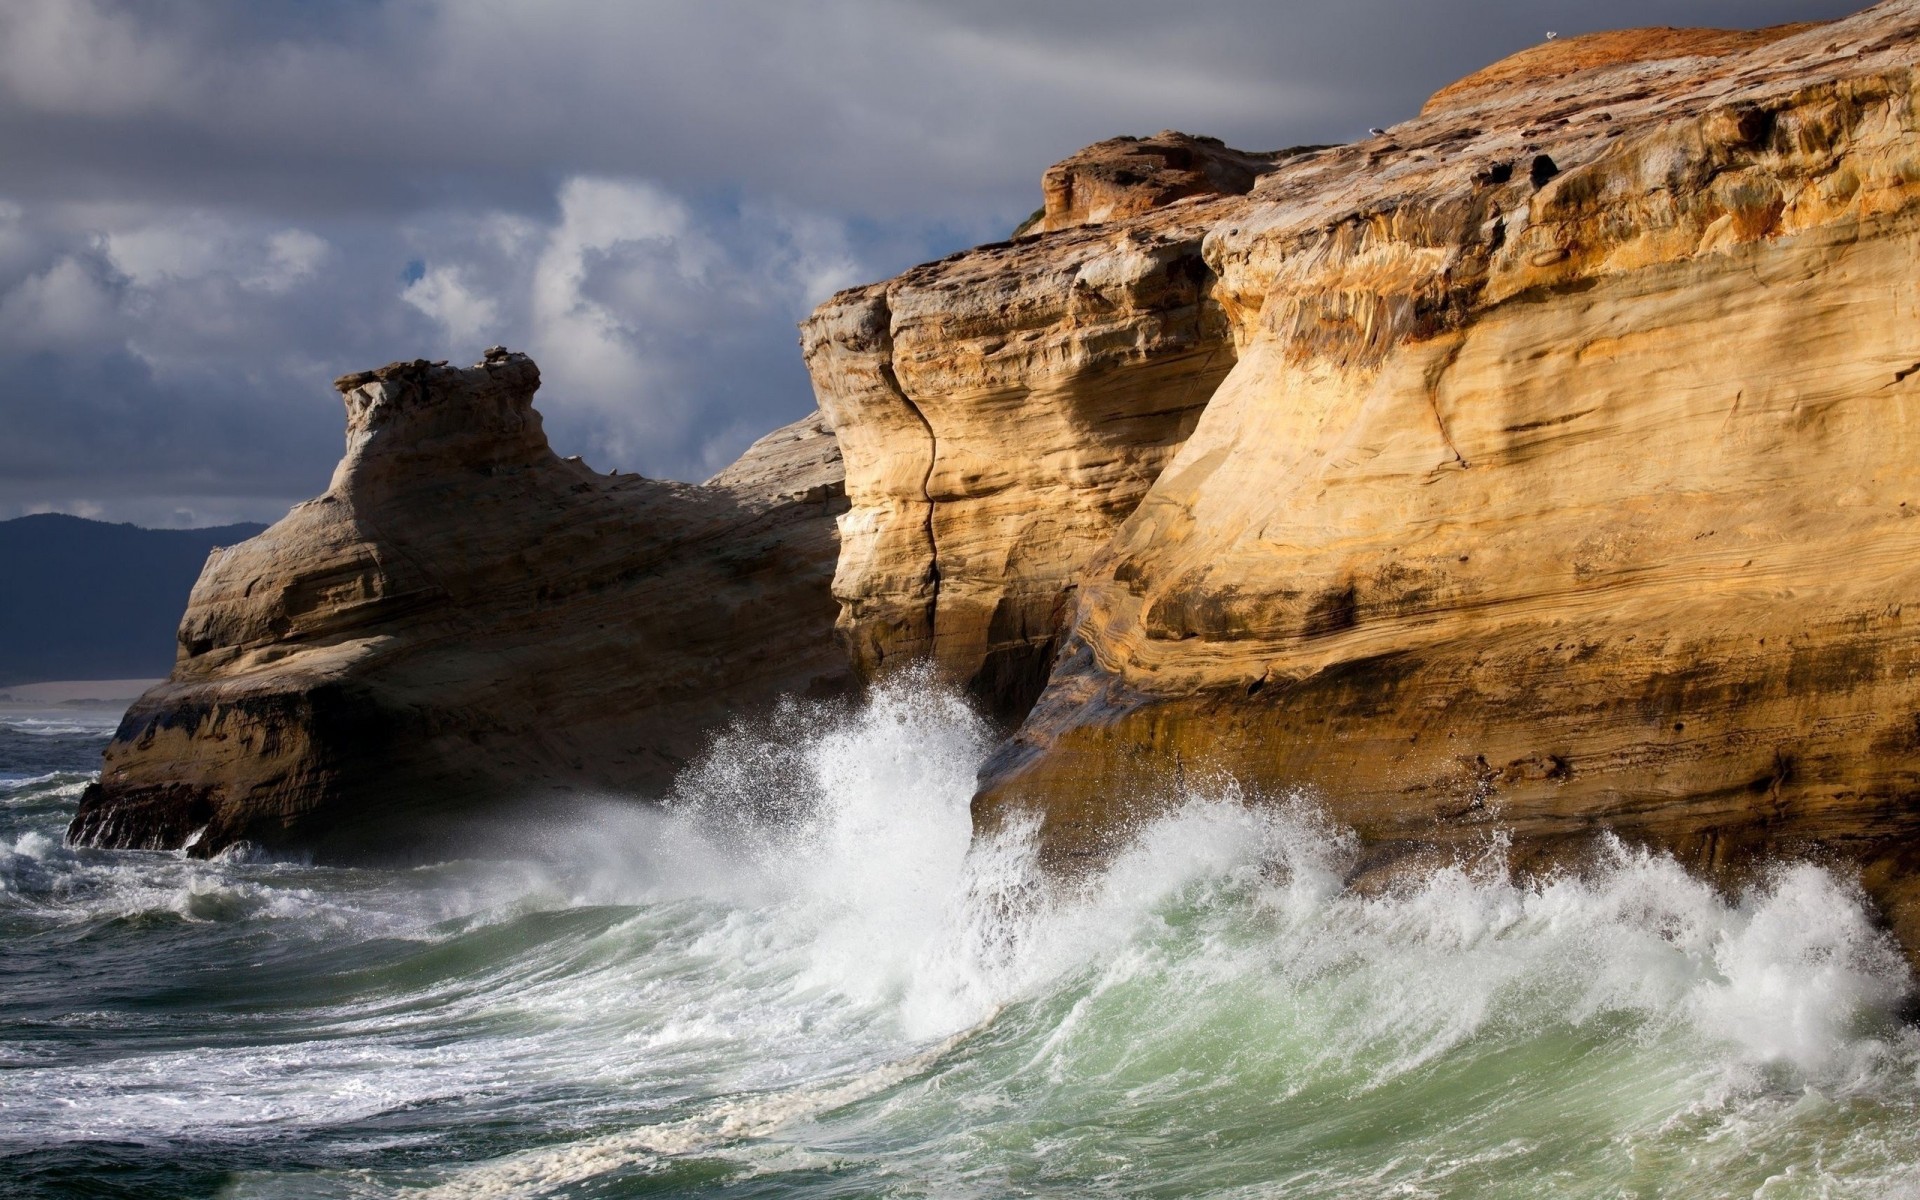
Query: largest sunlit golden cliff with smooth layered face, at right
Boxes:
[{"xmin": 979, "ymin": 4, "xmax": 1920, "ymax": 945}]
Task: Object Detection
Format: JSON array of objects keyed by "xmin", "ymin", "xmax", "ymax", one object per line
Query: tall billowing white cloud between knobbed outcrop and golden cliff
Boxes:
[{"xmin": 487, "ymin": 177, "xmax": 872, "ymax": 470}]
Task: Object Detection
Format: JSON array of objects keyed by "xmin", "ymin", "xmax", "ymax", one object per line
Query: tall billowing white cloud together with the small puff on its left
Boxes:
[{"xmin": 384, "ymin": 175, "xmax": 883, "ymax": 478}]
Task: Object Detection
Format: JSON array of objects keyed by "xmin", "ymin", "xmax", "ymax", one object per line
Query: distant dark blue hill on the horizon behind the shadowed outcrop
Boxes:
[{"xmin": 0, "ymin": 513, "xmax": 267, "ymax": 687}]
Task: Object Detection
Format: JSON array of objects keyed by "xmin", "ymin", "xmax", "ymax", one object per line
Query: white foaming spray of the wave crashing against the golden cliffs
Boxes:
[{"xmin": 303, "ymin": 682, "xmax": 1916, "ymax": 1198}]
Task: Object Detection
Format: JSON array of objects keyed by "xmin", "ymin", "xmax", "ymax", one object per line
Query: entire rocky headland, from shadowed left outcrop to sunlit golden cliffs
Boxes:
[{"xmin": 75, "ymin": 0, "xmax": 1920, "ymax": 947}]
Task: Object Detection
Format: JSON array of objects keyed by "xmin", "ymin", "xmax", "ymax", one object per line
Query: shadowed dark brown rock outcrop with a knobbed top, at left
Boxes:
[{"xmin": 69, "ymin": 351, "xmax": 849, "ymax": 858}]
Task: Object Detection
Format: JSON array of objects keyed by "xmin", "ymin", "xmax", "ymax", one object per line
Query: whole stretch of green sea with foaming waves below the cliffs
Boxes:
[{"xmin": 0, "ymin": 684, "xmax": 1920, "ymax": 1198}]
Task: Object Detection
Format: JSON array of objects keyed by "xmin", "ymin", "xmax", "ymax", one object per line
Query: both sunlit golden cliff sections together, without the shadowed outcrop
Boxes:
[{"xmin": 806, "ymin": 0, "xmax": 1920, "ymax": 947}]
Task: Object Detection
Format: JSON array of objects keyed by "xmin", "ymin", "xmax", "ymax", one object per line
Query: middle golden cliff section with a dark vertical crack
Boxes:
[{"xmin": 801, "ymin": 151, "xmax": 1258, "ymax": 720}]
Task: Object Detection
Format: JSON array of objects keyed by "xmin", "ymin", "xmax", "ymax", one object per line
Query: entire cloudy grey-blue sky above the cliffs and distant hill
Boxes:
[{"xmin": 0, "ymin": 0, "xmax": 1859, "ymax": 526}]
